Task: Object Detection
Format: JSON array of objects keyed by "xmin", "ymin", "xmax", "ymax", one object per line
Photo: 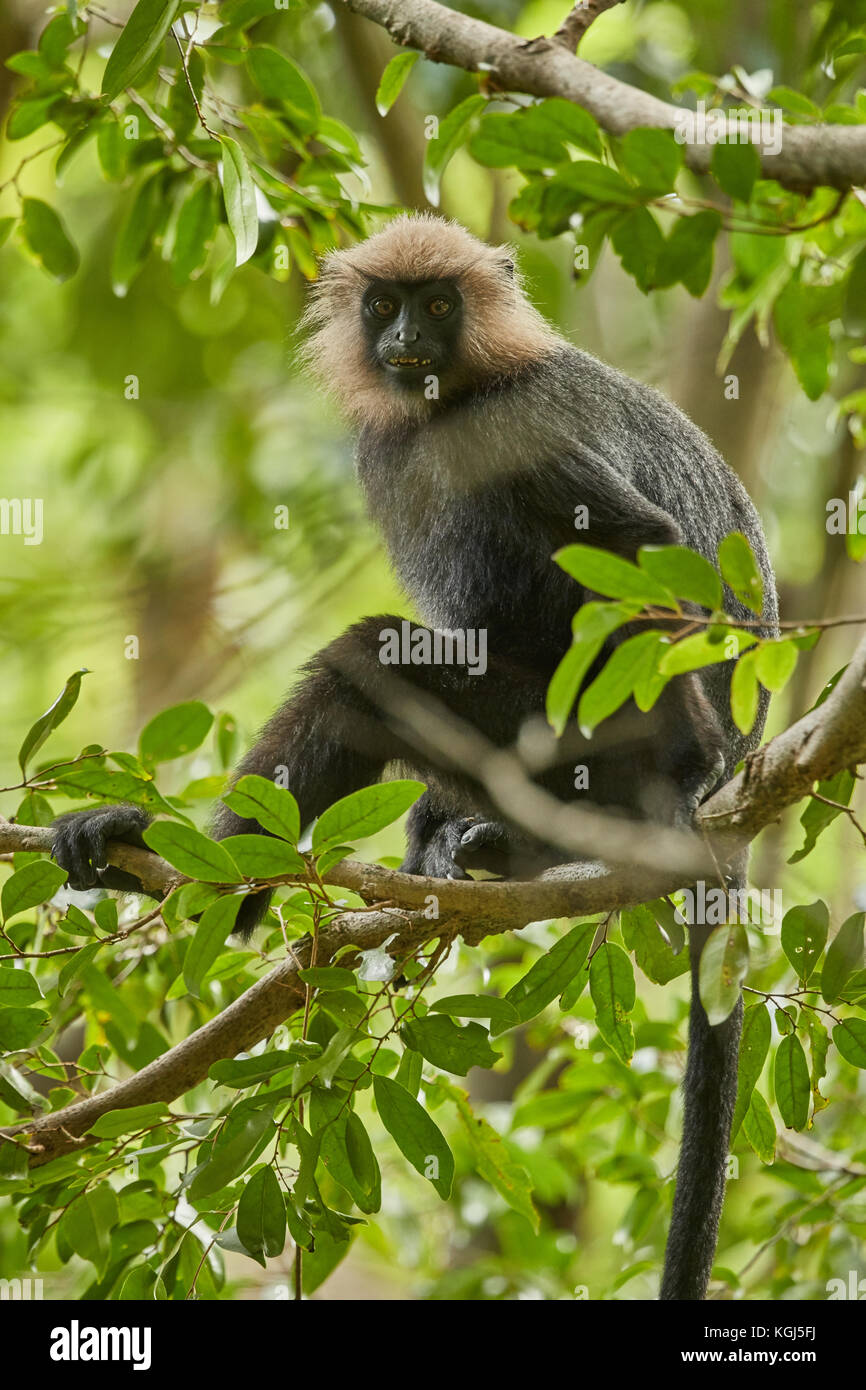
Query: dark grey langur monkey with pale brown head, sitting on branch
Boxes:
[{"xmin": 54, "ymin": 214, "xmax": 778, "ymax": 1300}]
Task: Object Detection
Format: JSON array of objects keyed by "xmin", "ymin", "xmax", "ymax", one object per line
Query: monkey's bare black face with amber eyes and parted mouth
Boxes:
[{"xmin": 361, "ymin": 279, "xmax": 463, "ymax": 395}]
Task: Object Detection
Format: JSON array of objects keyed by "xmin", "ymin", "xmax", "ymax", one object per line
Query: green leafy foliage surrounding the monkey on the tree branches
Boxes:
[{"xmin": 0, "ymin": 0, "xmax": 866, "ymax": 1300}]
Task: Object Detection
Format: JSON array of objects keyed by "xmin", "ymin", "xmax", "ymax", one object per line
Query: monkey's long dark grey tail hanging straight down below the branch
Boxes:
[{"xmin": 659, "ymin": 927, "xmax": 742, "ymax": 1300}]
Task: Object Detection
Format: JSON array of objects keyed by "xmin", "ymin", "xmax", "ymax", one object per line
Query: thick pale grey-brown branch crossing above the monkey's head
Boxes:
[{"xmin": 343, "ymin": 0, "xmax": 866, "ymax": 190}]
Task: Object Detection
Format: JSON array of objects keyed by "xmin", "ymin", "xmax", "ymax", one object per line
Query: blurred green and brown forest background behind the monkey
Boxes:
[{"xmin": 0, "ymin": 0, "xmax": 866, "ymax": 1297}]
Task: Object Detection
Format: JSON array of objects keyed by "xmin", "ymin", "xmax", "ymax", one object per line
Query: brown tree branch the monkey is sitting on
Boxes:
[{"xmin": 0, "ymin": 639, "xmax": 866, "ymax": 1165}]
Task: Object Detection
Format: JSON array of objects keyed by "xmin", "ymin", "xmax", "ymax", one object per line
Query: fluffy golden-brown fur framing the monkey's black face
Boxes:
[{"xmin": 303, "ymin": 213, "xmax": 562, "ymax": 425}]
